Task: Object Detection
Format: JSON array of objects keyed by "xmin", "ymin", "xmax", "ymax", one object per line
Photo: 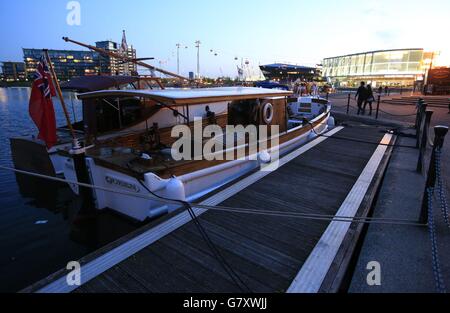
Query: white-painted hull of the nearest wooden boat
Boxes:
[{"xmin": 68, "ymin": 113, "xmax": 330, "ymax": 221}]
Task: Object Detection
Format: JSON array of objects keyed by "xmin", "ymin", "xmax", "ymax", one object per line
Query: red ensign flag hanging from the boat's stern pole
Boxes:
[{"xmin": 29, "ymin": 59, "xmax": 57, "ymax": 149}]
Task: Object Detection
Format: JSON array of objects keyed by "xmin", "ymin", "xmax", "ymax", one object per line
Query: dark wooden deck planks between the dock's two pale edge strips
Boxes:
[{"xmin": 74, "ymin": 128, "xmax": 383, "ymax": 292}]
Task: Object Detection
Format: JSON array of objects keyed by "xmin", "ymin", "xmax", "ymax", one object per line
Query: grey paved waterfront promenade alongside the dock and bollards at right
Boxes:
[{"xmin": 330, "ymin": 94, "xmax": 450, "ymax": 293}]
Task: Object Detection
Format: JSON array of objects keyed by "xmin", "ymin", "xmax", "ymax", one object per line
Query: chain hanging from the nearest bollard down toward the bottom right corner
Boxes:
[{"xmin": 427, "ymin": 187, "xmax": 446, "ymax": 293}]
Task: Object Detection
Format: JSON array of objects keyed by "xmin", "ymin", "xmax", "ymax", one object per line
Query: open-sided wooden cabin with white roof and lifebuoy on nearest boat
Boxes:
[{"xmin": 78, "ymin": 87, "xmax": 291, "ymax": 144}]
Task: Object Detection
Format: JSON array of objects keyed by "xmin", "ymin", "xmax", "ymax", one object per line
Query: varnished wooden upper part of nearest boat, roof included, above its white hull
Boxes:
[{"xmin": 67, "ymin": 87, "xmax": 328, "ymax": 177}]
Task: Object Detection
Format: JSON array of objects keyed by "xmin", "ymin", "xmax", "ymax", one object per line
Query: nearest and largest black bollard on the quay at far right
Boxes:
[{"xmin": 419, "ymin": 126, "xmax": 448, "ymax": 224}]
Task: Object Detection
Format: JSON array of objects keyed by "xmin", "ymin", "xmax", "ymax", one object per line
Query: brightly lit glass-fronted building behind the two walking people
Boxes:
[{"xmin": 322, "ymin": 49, "xmax": 434, "ymax": 87}]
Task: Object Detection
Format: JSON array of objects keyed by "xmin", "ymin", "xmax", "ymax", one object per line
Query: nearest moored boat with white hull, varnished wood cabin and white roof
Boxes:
[{"xmin": 58, "ymin": 87, "xmax": 333, "ymax": 221}]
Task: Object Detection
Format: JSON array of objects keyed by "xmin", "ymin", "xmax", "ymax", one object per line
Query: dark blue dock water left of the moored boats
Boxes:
[{"xmin": 0, "ymin": 88, "xmax": 139, "ymax": 292}]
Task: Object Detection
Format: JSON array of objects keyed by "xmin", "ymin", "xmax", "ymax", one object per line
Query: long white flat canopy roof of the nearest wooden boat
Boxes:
[{"xmin": 78, "ymin": 87, "xmax": 292, "ymax": 105}]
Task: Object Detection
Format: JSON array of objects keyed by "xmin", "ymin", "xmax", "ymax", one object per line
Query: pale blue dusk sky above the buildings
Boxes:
[{"xmin": 0, "ymin": 0, "xmax": 450, "ymax": 76}]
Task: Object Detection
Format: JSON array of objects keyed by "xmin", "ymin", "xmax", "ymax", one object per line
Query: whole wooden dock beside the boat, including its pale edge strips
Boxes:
[{"xmin": 24, "ymin": 125, "xmax": 395, "ymax": 293}]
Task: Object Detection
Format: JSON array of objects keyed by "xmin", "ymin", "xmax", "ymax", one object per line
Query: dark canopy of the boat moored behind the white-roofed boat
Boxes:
[{"xmin": 61, "ymin": 75, "xmax": 139, "ymax": 92}]
